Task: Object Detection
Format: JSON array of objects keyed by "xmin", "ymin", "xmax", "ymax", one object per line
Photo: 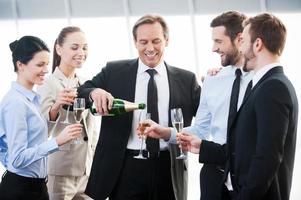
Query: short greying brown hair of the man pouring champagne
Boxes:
[{"xmin": 132, "ymin": 14, "xmax": 169, "ymax": 41}]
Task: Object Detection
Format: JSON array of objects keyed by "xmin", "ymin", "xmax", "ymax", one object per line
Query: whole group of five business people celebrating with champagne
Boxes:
[{"xmin": 0, "ymin": 11, "xmax": 298, "ymax": 200}]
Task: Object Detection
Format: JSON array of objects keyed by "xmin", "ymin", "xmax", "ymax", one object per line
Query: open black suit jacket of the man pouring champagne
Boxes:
[{"xmin": 78, "ymin": 59, "xmax": 200, "ymax": 199}]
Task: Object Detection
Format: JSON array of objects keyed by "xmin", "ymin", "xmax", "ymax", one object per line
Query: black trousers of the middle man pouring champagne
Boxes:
[{"xmin": 109, "ymin": 150, "xmax": 175, "ymax": 200}]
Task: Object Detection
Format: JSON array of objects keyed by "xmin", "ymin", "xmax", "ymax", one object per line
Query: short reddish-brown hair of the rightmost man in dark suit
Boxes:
[{"xmin": 243, "ymin": 13, "xmax": 286, "ymax": 56}]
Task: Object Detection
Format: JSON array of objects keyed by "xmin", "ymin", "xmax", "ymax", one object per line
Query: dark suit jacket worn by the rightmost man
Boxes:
[{"xmin": 199, "ymin": 67, "xmax": 298, "ymax": 200}]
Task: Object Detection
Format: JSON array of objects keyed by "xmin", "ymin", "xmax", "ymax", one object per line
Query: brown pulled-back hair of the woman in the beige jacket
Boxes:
[{"xmin": 52, "ymin": 26, "xmax": 83, "ymax": 73}]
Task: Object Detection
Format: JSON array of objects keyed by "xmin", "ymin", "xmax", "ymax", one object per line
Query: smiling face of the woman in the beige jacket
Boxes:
[{"xmin": 56, "ymin": 32, "xmax": 88, "ymax": 68}]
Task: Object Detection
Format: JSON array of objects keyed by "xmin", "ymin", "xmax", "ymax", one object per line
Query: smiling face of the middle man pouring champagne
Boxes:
[{"xmin": 135, "ymin": 22, "xmax": 168, "ymax": 67}]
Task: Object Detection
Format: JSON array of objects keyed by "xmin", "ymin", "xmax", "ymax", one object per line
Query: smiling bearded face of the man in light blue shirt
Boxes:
[{"xmin": 212, "ymin": 26, "xmax": 240, "ymax": 67}]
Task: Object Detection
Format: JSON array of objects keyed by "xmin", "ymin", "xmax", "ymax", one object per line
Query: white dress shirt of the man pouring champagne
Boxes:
[{"xmin": 127, "ymin": 59, "xmax": 169, "ymax": 150}]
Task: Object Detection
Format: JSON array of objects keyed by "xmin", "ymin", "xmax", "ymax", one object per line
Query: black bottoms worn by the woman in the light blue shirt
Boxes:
[{"xmin": 0, "ymin": 171, "xmax": 49, "ymax": 200}]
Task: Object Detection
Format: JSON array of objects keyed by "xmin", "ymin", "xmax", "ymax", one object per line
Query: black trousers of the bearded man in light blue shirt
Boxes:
[{"xmin": 200, "ymin": 164, "xmax": 224, "ymax": 200}]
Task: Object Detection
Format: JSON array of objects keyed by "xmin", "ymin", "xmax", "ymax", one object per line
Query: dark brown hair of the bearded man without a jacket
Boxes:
[{"xmin": 210, "ymin": 11, "xmax": 247, "ymax": 42}]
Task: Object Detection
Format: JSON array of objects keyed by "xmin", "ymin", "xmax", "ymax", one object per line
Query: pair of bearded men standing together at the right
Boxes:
[{"xmin": 139, "ymin": 11, "xmax": 298, "ymax": 200}]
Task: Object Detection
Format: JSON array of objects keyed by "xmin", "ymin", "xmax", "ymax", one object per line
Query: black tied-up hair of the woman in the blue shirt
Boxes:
[{"xmin": 9, "ymin": 36, "xmax": 50, "ymax": 72}]
